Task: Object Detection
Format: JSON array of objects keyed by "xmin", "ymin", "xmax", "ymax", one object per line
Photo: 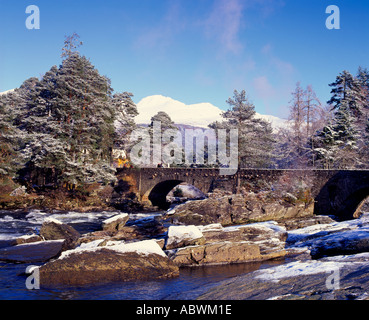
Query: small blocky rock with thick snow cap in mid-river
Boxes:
[{"xmin": 166, "ymin": 226, "xmax": 205, "ymax": 250}]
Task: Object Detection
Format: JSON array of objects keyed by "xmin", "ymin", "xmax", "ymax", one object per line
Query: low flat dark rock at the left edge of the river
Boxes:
[{"xmin": 0, "ymin": 240, "xmax": 64, "ymax": 263}]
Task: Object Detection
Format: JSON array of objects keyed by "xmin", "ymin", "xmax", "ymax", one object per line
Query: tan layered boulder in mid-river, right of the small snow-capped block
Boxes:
[{"xmin": 167, "ymin": 221, "xmax": 287, "ymax": 266}]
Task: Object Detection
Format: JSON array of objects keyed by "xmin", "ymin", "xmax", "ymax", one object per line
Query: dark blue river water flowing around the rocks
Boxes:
[{"xmin": 0, "ymin": 210, "xmax": 281, "ymax": 300}]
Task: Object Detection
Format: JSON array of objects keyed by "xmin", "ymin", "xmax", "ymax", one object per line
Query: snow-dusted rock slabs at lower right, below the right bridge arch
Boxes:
[{"xmin": 199, "ymin": 214, "xmax": 369, "ymax": 300}]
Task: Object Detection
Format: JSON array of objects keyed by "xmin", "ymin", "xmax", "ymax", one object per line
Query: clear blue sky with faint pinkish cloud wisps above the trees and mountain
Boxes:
[{"xmin": 0, "ymin": 0, "xmax": 369, "ymax": 117}]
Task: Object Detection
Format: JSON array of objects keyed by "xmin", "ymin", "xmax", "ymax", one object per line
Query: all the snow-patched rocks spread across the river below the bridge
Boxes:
[{"xmin": 0, "ymin": 192, "xmax": 369, "ymax": 300}]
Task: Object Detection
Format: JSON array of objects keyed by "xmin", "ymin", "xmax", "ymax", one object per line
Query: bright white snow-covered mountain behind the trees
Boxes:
[{"xmin": 135, "ymin": 95, "xmax": 287, "ymax": 129}]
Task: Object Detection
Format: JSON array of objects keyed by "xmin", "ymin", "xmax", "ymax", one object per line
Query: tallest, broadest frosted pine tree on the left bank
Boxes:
[{"xmin": 15, "ymin": 37, "xmax": 116, "ymax": 188}]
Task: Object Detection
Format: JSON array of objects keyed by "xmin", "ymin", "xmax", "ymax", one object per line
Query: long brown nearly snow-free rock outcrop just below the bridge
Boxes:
[{"xmin": 168, "ymin": 193, "xmax": 314, "ymax": 226}]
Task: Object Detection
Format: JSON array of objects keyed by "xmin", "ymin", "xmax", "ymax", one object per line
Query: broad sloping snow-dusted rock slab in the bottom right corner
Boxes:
[{"xmin": 198, "ymin": 253, "xmax": 369, "ymax": 300}]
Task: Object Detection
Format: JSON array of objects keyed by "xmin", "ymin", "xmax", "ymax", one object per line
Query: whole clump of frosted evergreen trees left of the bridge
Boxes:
[{"xmin": 0, "ymin": 34, "xmax": 137, "ymax": 189}]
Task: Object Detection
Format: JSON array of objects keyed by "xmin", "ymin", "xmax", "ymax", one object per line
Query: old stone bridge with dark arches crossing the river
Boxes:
[{"xmin": 117, "ymin": 168, "xmax": 369, "ymax": 219}]
